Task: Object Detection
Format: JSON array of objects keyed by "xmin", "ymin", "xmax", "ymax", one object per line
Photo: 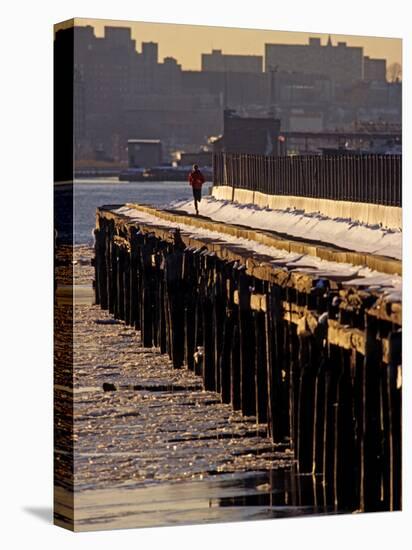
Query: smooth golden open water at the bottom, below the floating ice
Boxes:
[{"xmin": 55, "ymin": 469, "xmax": 339, "ymax": 531}]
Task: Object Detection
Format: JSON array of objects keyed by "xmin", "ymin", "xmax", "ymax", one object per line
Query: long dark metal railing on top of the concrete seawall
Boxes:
[{"xmin": 213, "ymin": 153, "xmax": 402, "ymax": 206}]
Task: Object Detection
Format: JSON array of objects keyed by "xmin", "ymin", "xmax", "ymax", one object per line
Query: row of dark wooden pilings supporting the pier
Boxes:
[{"xmin": 95, "ymin": 208, "xmax": 401, "ymax": 511}]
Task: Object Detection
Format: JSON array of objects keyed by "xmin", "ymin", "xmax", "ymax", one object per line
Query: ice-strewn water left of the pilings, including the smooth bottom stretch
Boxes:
[{"xmin": 55, "ymin": 246, "xmax": 338, "ymax": 530}]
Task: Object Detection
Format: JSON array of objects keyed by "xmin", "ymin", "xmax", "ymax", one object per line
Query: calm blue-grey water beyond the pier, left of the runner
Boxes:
[{"xmin": 74, "ymin": 178, "xmax": 210, "ymax": 244}]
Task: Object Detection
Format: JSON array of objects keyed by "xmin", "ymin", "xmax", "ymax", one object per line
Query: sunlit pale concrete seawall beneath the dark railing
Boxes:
[{"xmin": 211, "ymin": 185, "xmax": 402, "ymax": 229}]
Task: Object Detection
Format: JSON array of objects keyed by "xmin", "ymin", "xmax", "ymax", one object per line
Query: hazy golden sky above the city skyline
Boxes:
[{"xmin": 57, "ymin": 18, "xmax": 402, "ymax": 70}]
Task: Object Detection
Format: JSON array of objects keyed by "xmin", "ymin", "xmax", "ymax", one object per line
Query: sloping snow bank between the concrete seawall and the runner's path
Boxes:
[{"xmin": 168, "ymin": 196, "xmax": 402, "ymax": 260}]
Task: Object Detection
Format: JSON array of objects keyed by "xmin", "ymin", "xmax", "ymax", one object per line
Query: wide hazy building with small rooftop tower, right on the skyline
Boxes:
[{"xmin": 265, "ymin": 37, "xmax": 363, "ymax": 82}]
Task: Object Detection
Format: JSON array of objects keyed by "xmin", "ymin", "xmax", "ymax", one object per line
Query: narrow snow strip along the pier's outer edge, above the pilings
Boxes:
[{"xmin": 113, "ymin": 205, "xmax": 402, "ymax": 302}]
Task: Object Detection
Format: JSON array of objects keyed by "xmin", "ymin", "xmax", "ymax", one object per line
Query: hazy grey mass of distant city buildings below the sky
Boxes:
[{"xmin": 55, "ymin": 26, "xmax": 402, "ymax": 166}]
